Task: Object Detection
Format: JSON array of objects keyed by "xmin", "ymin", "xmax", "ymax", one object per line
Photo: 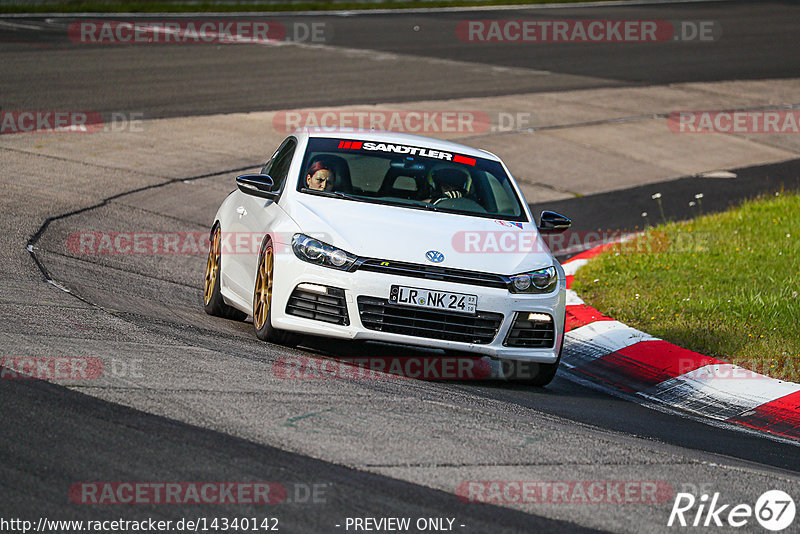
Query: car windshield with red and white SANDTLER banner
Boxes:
[{"xmin": 297, "ymin": 138, "xmax": 527, "ymax": 222}]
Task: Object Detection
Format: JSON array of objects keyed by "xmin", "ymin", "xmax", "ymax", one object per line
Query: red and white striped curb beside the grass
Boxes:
[{"xmin": 561, "ymin": 244, "xmax": 800, "ymax": 440}]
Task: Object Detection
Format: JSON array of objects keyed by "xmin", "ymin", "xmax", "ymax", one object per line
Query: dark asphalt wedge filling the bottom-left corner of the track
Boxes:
[{"xmin": 0, "ymin": 374, "xmax": 596, "ymax": 533}]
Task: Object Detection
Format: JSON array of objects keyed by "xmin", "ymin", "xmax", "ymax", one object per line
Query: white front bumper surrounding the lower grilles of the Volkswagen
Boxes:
[{"xmin": 272, "ymin": 253, "xmax": 566, "ymax": 363}]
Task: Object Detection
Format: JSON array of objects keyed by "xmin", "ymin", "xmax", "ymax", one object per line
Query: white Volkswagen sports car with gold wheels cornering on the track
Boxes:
[{"xmin": 204, "ymin": 129, "xmax": 570, "ymax": 385}]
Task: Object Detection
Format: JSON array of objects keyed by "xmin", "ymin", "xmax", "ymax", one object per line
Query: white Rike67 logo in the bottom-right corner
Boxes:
[{"xmin": 667, "ymin": 490, "xmax": 796, "ymax": 532}]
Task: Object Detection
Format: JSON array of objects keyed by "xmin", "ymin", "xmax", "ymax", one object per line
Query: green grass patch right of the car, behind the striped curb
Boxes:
[{"xmin": 574, "ymin": 193, "xmax": 800, "ymax": 382}]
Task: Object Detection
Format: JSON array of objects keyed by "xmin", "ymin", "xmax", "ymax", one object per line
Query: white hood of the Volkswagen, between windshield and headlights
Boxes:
[{"xmin": 287, "ymin": 194, "xmax": 555, "ymax": 275}]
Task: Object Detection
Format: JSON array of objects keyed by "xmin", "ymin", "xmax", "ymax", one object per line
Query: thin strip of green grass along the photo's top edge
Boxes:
[{"xmin": 0, "ymin": 0, "xmax": 620, "ymax": 13}]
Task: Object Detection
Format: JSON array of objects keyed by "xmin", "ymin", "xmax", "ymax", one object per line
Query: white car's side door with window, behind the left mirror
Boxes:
[{"xmin": 234, "ymin": 137, "xmax": 297, "ymax": 302}]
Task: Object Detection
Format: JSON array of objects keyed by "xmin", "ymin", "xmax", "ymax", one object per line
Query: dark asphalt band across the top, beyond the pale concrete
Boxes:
[{"xmin": 0, "ymin": 2, "xmax": 800, "ymax": 118}]
